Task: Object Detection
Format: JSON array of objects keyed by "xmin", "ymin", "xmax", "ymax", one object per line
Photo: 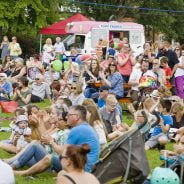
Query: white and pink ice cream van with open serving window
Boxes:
[{"xmin": 63, "ymin": 21, "xmax": 145, "ymax": 56}]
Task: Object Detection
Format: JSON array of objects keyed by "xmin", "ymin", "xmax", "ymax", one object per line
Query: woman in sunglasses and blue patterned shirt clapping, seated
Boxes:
[{"xmin": 100, "ymin": 61, "xmax": 124, "ymax": 99}]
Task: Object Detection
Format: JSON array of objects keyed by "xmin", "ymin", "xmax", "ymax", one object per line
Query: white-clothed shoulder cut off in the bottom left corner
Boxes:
[{"xmin": 0, "ymin": 160, "xmax": 15, "ymax": 184}]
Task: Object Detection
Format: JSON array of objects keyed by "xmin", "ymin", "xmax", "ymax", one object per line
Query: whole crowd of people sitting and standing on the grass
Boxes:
[{"xmin": 0, "ymin": 36, "xmax": 184, "ymax": 184}]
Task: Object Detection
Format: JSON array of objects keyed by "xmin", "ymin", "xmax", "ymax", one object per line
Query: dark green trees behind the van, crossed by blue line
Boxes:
[{"xmin": 70, "ymin": 0, "xmax": 184, "ymax": 40}]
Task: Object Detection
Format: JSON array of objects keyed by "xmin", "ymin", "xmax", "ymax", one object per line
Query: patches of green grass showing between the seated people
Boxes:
[{"xmin": 0, "ymin": 101, "xmax": 172, "ymax": 184}]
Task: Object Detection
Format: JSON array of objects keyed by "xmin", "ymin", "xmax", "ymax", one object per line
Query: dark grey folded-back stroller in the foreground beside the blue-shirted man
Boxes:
[{"xmin": 92, "ymin": 110, "xmax": 161, "ymax": 184}]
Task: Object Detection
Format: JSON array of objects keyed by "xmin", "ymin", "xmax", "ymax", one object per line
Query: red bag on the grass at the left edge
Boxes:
[{"xmin": 0, "ymin": 101, "xmax": 18, "ymax": 113}]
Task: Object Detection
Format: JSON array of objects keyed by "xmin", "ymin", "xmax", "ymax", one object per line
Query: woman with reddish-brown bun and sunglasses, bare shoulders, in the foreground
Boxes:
[{"xmin": 56, "ymin": 144, "xmax": 99, "ymax": 184}]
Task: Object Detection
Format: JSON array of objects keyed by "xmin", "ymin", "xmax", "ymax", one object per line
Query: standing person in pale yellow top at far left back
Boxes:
[{"xmin": 8, "ymin": 36, "xmax": 22, "ymax": 59}]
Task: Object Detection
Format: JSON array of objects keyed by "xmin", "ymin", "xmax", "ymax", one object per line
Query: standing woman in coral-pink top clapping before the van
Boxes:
[{"xmin": 117, "ymin": 44, "xmax": 135, "ymax": 83}]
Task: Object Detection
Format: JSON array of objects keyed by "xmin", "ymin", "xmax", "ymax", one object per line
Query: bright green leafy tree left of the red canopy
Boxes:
[{"xmin": 0, "ymin": 0, "xmax": 59, "ymax": 35}]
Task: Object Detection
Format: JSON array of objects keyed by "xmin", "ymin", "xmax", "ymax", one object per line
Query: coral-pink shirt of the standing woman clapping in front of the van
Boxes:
[{"xmin": 118, "ymin": 53, "xmax": 132, "ymax": 76}]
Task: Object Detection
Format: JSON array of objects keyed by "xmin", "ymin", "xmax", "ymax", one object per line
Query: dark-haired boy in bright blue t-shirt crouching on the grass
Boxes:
[{"xmin": 145, "ymin": 100, "xmax": 173, "ymax": 150}]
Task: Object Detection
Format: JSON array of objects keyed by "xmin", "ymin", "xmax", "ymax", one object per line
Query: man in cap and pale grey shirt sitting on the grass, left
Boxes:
[{"xmin": 31, "ymin": 74, "xmax": 51, "ymax": 102}]
